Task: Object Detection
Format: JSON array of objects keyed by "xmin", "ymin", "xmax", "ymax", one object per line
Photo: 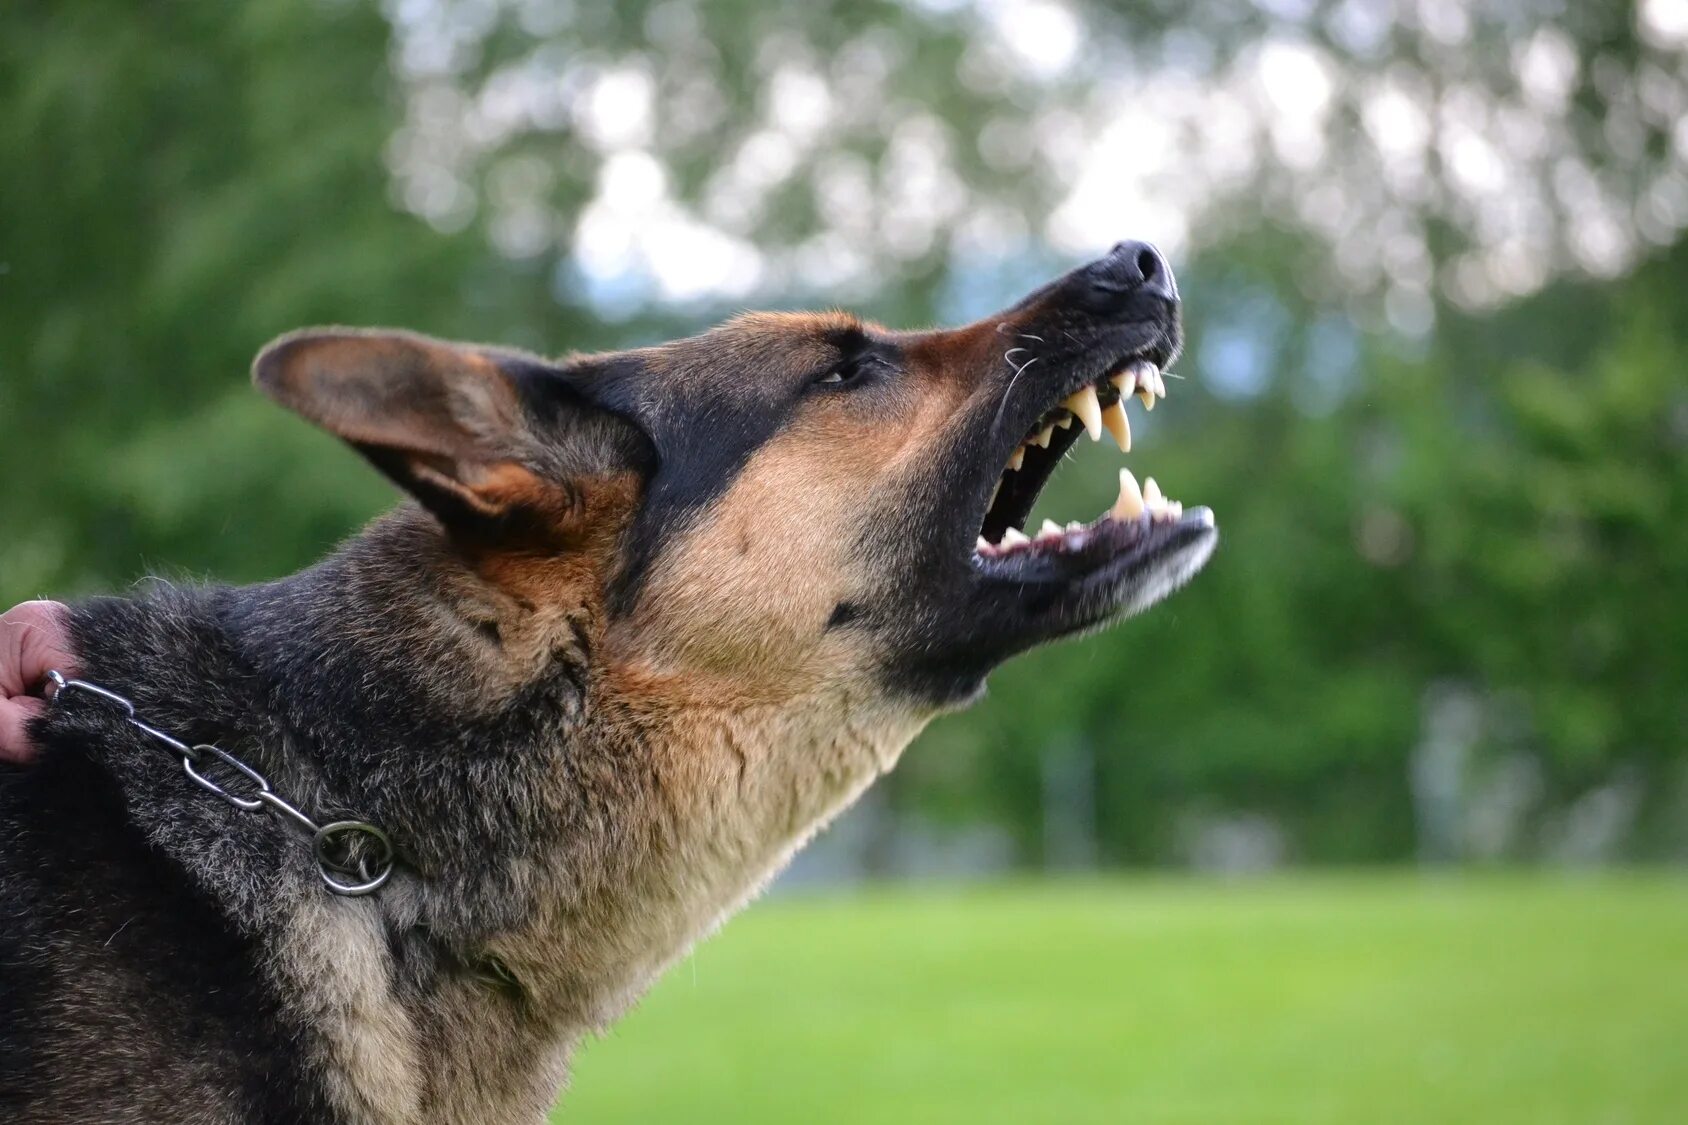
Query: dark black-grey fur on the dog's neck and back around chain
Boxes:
[{"xmin": 0, "ymin": 533, "xmax": 624, "ymax": 1125}]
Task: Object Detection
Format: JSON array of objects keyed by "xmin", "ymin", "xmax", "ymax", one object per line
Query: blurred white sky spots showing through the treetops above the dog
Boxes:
[{"xmin": 379, "ymin": 0, "xmax": 1688, "ymax": 331}]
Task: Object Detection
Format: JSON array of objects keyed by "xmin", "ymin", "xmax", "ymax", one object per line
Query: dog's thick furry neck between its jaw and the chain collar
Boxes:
[{"xmin": 188, "ymin": 512, "xmax": 925, "ymax": 1122}]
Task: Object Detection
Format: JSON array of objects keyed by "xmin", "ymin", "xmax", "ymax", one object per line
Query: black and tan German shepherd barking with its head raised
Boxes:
[{"xmin": 0, "ymin": 243, "xmax": 1217, "ymax": 1125}]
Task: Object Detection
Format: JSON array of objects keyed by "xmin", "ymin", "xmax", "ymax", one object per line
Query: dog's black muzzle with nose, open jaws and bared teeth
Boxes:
[{"xmin": 896, "ymin": 242, "xmax": 1219, "ymax": 682}]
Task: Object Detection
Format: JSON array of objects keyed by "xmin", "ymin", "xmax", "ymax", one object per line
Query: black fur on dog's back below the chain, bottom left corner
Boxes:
[{"xmin": 0, "ymin": 703, "xmax": 341, "ymax": 1125}]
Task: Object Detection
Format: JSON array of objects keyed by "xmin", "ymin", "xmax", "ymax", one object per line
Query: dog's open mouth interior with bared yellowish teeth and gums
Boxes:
[{"xmin": 974, "ymin": 355, "xmax": 1214, "ymax": 579}]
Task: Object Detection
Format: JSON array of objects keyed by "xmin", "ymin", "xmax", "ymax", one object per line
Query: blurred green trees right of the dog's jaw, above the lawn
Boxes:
[{"xmin": 910, "ymin": 236, "xmax": 1688, "ymax": 861}]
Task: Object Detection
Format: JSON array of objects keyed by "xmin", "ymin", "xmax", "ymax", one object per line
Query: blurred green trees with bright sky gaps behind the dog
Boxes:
[{"xmin": 0, "ymin": 0, "xmax": 1688, "ymax": 861}]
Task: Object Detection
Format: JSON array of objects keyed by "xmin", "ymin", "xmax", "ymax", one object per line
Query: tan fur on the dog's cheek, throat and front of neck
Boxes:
[{"xmin": 278, "ymin": 314, "xmax": 966, "ymax": 1123}]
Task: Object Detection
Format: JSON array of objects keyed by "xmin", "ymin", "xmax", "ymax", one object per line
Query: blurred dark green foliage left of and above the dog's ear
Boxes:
[{"xmin": 0, "ymin": 2, "xmax": 481, "ymax": 598}]
